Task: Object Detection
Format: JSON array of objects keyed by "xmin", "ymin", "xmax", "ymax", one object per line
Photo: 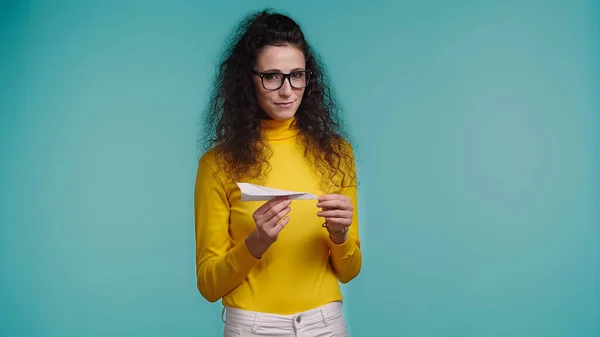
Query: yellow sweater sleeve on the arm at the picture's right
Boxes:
[{"xmin": 329, "ymin": 149, "xmax": 362, "ymax": 283}]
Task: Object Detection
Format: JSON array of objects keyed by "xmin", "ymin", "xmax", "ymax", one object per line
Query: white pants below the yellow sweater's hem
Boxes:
[{"xmin": 221, "ymin": 302, "xmax": 348, "ymax": 337}]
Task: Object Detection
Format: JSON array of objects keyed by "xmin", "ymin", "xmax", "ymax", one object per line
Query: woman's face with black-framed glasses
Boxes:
[{"xmin": 254, "ymin": 45, "xmax": 307, "ymax": 120}]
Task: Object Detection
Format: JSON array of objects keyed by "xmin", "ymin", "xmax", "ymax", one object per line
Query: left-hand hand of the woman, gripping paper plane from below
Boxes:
[{"xmin": 246, "ymin": 197, "xmax": 292, "ymax": 259}]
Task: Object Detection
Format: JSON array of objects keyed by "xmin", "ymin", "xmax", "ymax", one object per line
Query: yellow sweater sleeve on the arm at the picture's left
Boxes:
[{"xmin": 194, "ymin": 157, "xmax": 259, "ymax": 302}]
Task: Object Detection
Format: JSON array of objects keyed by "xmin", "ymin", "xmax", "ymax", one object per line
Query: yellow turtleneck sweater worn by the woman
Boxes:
[{"xmin": 194, "ymin": 119, "xmax": 362, "ymax": 314}]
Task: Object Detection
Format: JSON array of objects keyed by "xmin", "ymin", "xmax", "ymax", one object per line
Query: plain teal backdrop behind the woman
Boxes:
[{"xmin": 0, "ymin": 0, "xmax": 600, "ymax": 337}]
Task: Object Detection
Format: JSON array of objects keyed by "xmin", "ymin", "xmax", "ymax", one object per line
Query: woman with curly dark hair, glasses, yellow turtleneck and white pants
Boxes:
[{"xmin": 195, "ymin": 11, "xmax": 362, "ymax": 336}]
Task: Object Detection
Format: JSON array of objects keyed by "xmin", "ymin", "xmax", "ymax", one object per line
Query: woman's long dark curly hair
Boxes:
[{"xmin": 203, "ymin": 10, "xmax": 356, "ymax": 189}]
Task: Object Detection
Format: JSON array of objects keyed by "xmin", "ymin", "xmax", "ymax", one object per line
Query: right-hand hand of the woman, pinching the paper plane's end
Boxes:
[{"xmin": 317, "ymin": 194, "xmax": 354, "ymax": 232}]
